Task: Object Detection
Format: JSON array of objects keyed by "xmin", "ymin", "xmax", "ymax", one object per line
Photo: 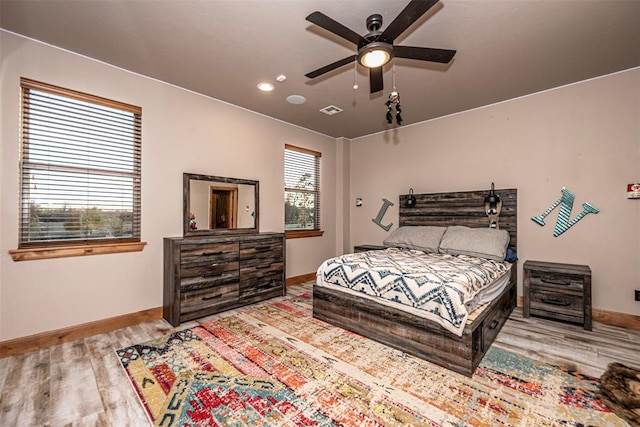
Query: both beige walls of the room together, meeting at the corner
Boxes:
[{"xmin": 0, "ymin": 31, "xmax": 640, "ymax": 341}]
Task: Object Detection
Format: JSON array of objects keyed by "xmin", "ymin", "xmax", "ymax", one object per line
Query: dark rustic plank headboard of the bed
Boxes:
[{"xmin": 399, "ymin": 188, "xmax": 518, "ymax": 252}]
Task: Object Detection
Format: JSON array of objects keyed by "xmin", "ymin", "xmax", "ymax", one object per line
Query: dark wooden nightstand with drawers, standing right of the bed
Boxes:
[{"xmin": 522, "ymin": 261, "xmax": 592, "ymax": 331}]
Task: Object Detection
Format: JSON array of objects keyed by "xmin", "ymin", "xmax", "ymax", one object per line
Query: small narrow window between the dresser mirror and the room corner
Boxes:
[{"xmin": 284, "ymin": 145, "xmax": 322, "ymax": 238}]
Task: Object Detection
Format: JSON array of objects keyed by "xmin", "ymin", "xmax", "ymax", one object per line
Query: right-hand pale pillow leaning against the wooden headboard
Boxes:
[{"xmin": 440, "ymin": 225, "xmax": 509, "ymax": 261}]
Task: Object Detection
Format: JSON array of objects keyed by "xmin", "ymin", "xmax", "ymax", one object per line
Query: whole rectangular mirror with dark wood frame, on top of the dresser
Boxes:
[{"xmin": 182, "ymin": 173, "xmax": 259, "ymax": 237}]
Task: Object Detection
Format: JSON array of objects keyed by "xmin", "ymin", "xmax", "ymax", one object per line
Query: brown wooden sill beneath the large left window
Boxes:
[{"xmin": 9, "ymin": 242, "xmax": 147, "ymax": 261}]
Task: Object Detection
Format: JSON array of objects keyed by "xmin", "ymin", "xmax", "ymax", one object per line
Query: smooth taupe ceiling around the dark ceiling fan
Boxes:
[{"xmin": 0, "ymin": 0, "xmax": 640, "ymax": 138}]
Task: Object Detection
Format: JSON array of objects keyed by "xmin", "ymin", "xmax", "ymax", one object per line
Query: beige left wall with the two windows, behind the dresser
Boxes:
[{"xmin": 0, "ymin": 31, "xmax": 338, "ymax": 341}]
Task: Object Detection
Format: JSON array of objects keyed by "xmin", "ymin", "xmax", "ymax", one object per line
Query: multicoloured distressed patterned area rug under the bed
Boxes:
[{"xmin": 117, "ymin": 295, "xmax": 627, "ymax": 427}]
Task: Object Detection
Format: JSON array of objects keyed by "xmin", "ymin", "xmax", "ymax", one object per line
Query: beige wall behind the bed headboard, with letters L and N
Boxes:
[{"xmin": 350, "ymin": 69, "xmax": 640, "ymax": 315}]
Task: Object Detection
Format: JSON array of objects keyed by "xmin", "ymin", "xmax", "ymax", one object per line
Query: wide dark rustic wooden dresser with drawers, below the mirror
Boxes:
[{"xmin": 163, "ymin": 233, "xmax": 286, "ymax": 326}]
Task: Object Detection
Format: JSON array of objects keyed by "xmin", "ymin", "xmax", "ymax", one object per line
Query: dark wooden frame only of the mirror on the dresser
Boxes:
[{"xmin": 182, "ymin": 172, "xmax": 260, "ymax": 237}]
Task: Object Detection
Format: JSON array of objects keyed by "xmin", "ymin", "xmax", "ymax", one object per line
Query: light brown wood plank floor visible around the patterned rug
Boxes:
[{"xmin": 0, "ymin": 282, "xmax": 640, "ymax": 427}]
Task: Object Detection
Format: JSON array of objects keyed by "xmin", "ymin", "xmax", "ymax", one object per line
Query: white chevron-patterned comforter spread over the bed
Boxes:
[{"xmin": 317, "ymin": 248, "xmax": 508, "ymax": 336}]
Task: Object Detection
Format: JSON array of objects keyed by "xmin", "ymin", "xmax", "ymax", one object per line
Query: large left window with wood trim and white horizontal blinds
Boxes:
[{"xmin": 12, "ymin": 78, "xmax": 142, "ymax": 259}]
